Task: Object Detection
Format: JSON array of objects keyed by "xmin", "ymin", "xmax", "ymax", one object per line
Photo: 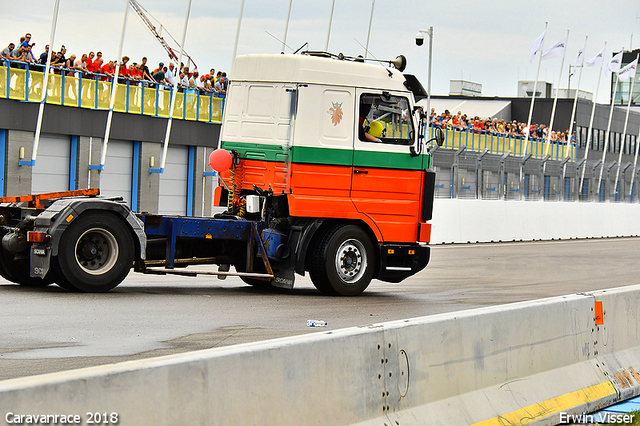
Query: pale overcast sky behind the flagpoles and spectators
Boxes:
[{"xmin": 0, "ymin": 0, "xmax": 640, "ymax": 102}]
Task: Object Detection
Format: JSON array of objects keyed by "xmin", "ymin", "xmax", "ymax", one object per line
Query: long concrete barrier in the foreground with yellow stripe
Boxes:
[{"xmin": 0, "ymin": 286, "xmax": 640, "ymax": 426}]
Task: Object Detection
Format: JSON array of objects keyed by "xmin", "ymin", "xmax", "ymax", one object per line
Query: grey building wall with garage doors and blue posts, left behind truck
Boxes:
[{"xmin": 0, "ymin": 99, "xmax": 220, "ymax": 216}]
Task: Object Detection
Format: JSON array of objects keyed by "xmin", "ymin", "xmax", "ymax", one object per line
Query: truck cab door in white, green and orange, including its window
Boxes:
[{"xmin": 350, "ymin": 89, "xmax": 423, "ymax": 242}]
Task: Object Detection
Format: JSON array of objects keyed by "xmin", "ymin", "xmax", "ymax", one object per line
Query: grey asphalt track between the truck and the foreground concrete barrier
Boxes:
[{"xmin": 0, "ymin": 238, "xmax": 640, "ymax": 380}]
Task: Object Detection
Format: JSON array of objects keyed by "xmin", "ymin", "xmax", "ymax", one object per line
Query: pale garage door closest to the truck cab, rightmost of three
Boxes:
[{"xmin": 158, "ymin": 146, "xmax": 189, "ymax": 215}]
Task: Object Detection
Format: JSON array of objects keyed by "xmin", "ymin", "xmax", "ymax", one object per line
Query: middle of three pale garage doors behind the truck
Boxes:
[{"xmin": 100, "ymin": 140, "xmax": 133, "ymax": 207}]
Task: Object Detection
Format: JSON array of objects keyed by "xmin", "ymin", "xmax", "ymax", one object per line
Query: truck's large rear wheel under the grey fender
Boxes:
[{"xmin": 52, "ymin": 211, "xmax": 135, "ymax": 293}]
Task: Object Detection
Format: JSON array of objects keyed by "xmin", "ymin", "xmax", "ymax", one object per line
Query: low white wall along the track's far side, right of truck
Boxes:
[{"xmin": 431, "ymin": 198, "xmax": 640, "ymax": 244}]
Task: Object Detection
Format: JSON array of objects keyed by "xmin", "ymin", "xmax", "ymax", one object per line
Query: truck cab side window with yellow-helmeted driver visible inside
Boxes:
[{"xmin": 358, "ymin": 93, "xmax": 413, "ymax": 145}]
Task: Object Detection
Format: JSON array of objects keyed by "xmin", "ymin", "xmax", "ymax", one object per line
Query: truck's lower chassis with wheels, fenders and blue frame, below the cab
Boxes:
[{"xmin": 0, "ymin": 190, "xmax": 429, "ymax": 296}]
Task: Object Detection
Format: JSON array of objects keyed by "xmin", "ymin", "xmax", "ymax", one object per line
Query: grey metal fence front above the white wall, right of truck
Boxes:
[{"xmin": 433, "ymin": 143, "xmax": 638, "ymax": 202}]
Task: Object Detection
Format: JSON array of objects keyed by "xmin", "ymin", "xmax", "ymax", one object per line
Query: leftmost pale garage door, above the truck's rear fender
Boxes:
[{"xmin": 31, "ymin": 134, "xmax": 71, "ymax": 194}]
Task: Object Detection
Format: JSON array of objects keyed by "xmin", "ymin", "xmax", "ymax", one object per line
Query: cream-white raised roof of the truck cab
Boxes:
[{"xmin": 231, "ymin": 55, "xmax": 408, "ymax": 92}]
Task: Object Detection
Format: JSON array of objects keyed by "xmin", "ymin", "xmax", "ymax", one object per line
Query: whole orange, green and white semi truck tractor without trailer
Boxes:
[{"xmin": 0, "ymin": 52, "xmax": 442, "ymax": 296}]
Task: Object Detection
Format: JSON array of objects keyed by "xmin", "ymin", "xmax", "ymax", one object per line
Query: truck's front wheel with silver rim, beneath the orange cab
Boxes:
[{"xmin": 309, "ymin": 225, "xmax": 376, "ymax": 296}]
